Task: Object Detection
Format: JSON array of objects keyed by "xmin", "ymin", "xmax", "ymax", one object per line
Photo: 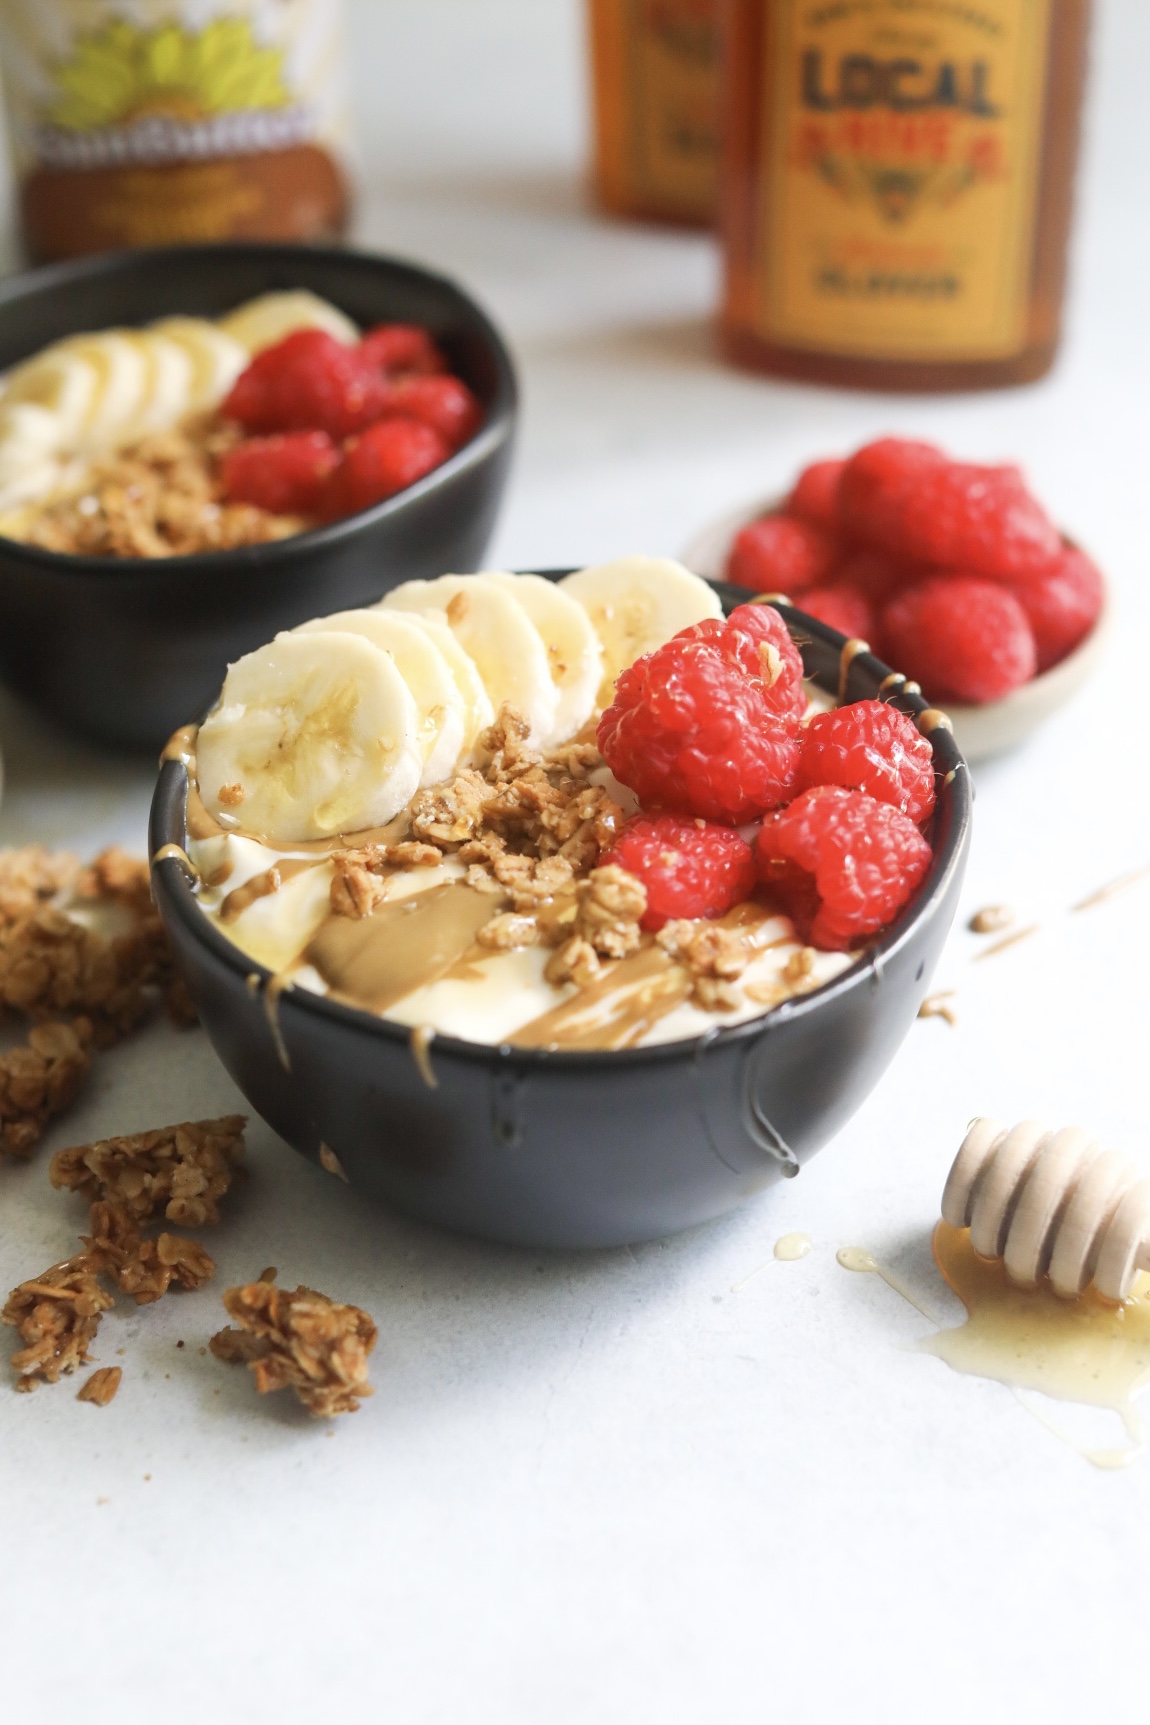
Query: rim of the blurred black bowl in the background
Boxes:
[{"xmin": 0, "ymin": 240, "xmax": 519, "ymax": 581}]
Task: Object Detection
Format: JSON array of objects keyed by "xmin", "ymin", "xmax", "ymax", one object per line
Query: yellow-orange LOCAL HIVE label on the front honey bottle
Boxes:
[{"xmin": 755, "ymin": 0, "xmax": 1050, "ymax": 359}]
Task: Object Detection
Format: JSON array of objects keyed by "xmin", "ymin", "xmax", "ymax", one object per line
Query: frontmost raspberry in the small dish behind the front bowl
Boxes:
[{"xmin": 881, "ymin": 574, "xmax": 1038, "ymax": 704}]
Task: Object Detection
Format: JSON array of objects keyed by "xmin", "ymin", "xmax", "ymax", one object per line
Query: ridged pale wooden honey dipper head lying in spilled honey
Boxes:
[{"xmin": 943, "ymin": 1120, "xmax": 1150, "ymax": 1302}]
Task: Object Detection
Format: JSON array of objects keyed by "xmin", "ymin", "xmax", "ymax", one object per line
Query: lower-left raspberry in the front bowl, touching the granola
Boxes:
[{"xmin": 600, "ymin": 814, "xmax": 755, "ymax": 933}]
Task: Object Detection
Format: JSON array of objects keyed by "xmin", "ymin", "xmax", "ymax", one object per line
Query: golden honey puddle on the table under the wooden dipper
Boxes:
[{"xmin": 838, "ymin": 1221, "xmax": 1150, "ymax": 1468}]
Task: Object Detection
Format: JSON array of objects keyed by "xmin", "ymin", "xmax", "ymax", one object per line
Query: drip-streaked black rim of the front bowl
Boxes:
[{"xmin": 148, "ymin": 569, "xmax": 974, "ymax": 1071}]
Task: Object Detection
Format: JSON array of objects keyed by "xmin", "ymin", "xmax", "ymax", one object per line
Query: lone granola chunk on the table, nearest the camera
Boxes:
[{"xmin": 209, "ymin": 1280, "xmax": 378, "ymax": 1420}]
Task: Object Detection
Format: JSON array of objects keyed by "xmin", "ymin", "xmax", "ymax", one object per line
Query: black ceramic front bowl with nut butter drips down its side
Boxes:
[{"xmin": 150, "ymin": 583, "xmax": 971, "ymax": 1245}]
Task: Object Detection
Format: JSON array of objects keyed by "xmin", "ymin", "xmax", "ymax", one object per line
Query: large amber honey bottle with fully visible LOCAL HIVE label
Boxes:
[{"xmin": 722, "ymin": 0, "xmax": 1090, "ymax": 390}]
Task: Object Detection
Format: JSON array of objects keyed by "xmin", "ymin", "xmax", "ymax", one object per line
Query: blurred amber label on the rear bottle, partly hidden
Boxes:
[{"xmin": 624, "ymin": 0, "xmax": 719, "ymax": 217}]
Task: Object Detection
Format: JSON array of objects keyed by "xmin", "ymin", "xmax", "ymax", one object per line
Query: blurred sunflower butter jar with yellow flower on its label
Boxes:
[{"xmin": 0, "ymin": 0, "xmax": 348, "ymax": 262}]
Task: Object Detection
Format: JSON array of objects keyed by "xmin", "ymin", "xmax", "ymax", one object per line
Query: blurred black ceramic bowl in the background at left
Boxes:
[{"xmin": 0, "ymin": 245, "xmax": 516, "ymax": 749}]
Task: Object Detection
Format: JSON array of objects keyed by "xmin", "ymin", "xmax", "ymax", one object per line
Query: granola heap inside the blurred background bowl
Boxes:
[{"xmin": 0, "ymin": 416, "xmax": 307, "ymax": 557}]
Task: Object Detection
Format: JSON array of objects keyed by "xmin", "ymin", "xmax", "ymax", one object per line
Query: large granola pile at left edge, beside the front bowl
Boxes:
[{"xmin": 0, "ymin": 845, "xmax": 195, "ymax": 1156}]
